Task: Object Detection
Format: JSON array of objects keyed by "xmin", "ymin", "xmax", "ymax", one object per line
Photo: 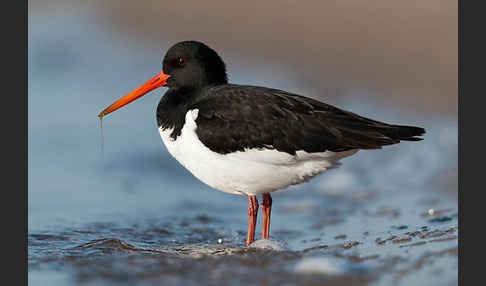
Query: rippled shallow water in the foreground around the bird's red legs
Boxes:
[{"xmin": 28, "ymin": 175, "xmax": 458, "ymax": 285}]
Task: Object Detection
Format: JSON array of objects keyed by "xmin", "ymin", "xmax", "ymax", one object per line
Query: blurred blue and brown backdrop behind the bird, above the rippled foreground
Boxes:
[{"xmin": 28, "ymin": 0, "xmax": 458, "ymax": 281}]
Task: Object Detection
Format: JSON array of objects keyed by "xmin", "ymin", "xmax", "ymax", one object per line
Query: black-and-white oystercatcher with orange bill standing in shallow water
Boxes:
[{"xmin": 98, "ymin": 40, "xmax": 425, "ymax": 247}]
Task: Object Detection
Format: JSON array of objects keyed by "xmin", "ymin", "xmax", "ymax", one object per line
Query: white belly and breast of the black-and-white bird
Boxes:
[{"xmin": 159, "ymin": 109, "xmax": 358, "ymax": 195}]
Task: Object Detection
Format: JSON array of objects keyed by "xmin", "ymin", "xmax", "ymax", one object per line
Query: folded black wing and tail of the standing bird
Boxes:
[{"xmin": 191, "ymin": 85, "xmax": 425, "ymax": 155}]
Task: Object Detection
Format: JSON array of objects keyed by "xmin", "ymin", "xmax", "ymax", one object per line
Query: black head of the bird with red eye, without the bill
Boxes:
[{"xmin": 162, "ymin": 41, "xmax": 228, "ymax": 89}]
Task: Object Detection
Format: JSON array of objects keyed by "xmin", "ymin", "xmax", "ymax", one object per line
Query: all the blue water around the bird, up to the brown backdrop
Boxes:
[{"xmin": 28, "ymin": 2, "xmax": 459, "ymax": 285}]
